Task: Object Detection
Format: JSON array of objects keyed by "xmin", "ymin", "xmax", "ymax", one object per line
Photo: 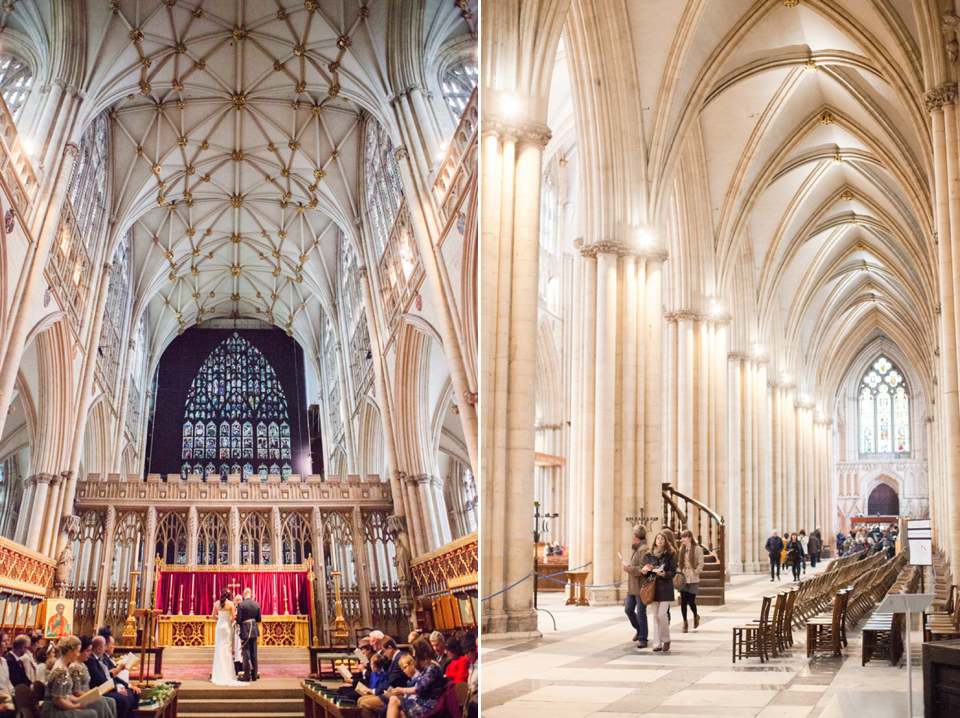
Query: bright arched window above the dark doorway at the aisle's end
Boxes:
[{"xmin": 858, "ymin": 356, "xmax": 910, "ymax": 455}]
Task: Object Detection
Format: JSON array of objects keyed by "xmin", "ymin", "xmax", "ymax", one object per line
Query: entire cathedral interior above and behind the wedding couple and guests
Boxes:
[{"xmin": 0, "ymin": 0, "xmax": 479, "ymax": 646}]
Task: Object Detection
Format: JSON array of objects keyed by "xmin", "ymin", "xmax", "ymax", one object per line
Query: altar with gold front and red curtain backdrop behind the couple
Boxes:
[{"xmin": 154, "ymin": 556, "xmax": 316, "ymax": 647}]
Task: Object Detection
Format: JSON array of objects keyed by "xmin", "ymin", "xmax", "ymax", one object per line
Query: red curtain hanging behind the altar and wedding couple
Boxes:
[{"xmin": 157, "ymin": 571, "xmax": 310, "ymax": 616}]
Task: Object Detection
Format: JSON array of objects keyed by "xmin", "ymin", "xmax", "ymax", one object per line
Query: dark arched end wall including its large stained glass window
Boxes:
[{"xmin": 147, "ymin": 328, "xmax": 312, "ymax": 481}]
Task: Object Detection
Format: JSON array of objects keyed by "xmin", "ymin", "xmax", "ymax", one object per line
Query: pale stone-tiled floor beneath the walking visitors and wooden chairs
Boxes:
[{"xmin": 481, "ymin": 565, "xmax": 923, "ymax": 718}]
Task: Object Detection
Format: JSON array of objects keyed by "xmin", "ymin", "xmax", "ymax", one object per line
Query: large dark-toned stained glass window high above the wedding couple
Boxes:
[{"xmin": 181, "ymin": 332, "xmax": 293, "ymax": 480}]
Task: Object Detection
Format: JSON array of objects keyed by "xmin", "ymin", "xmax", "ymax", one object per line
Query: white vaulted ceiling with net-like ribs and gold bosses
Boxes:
[{"xmin": 7, "ymin": 0, "xmax": 475, "ymax": 366}]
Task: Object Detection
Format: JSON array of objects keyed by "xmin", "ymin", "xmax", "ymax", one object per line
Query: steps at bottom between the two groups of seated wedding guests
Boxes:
[{"xmin": 177, "ymin": 680, "xmax": 303, "ymax": 718}]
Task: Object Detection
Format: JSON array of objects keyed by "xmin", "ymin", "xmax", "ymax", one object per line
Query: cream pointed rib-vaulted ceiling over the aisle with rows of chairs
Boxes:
[{"xmin": 548, "ymin": 0, "xmax": 940, "ymax": 401}]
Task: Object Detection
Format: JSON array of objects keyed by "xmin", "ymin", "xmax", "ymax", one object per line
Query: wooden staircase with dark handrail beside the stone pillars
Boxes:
[{"xmin": 663, "ymin": 484, "xmax": 726, "ymax": 606}]
